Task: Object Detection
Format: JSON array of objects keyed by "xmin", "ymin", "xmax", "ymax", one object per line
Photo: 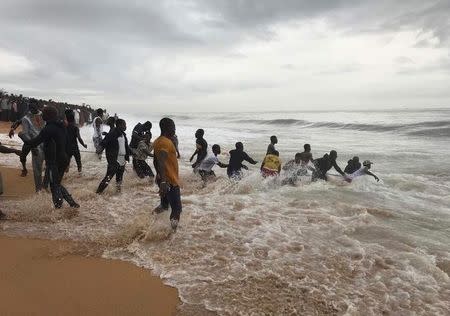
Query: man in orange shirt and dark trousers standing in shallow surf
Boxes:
[{"xmin": 153, "ymin": 117, "xmax": 182, "ymax": 230}]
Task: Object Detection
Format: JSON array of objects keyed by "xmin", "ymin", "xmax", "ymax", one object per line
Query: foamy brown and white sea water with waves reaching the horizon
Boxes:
[{"xmin": 0, "ymin": 109, "xmax": 450, "ymax": 315}]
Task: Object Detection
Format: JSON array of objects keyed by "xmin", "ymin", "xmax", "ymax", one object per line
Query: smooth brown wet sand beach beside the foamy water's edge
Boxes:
[{"xmin": 0, "ymin": 122, "xmax": 180, "ymax": 315}]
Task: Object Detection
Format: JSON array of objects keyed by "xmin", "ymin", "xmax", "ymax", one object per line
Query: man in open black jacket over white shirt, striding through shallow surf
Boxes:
[{"xmin": 97, "ymin": 119, "xmax": 130, "ymax": 194}]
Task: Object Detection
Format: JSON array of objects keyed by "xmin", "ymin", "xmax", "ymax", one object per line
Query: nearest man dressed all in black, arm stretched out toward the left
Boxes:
[{"xmin": 25, "ymin": 106, "xmax": 80, "ymax": 208}]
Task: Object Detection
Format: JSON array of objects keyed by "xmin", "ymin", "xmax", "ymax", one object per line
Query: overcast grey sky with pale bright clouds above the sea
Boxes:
[{"xmin": 0, "ymin": 0, "xmax": 450, "ymax": 113}]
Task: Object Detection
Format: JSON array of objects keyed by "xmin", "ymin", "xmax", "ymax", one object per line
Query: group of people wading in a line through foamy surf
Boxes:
[{"xmin": 0, "ymin": 105, "xmax": 379, "ymax": 230}]
